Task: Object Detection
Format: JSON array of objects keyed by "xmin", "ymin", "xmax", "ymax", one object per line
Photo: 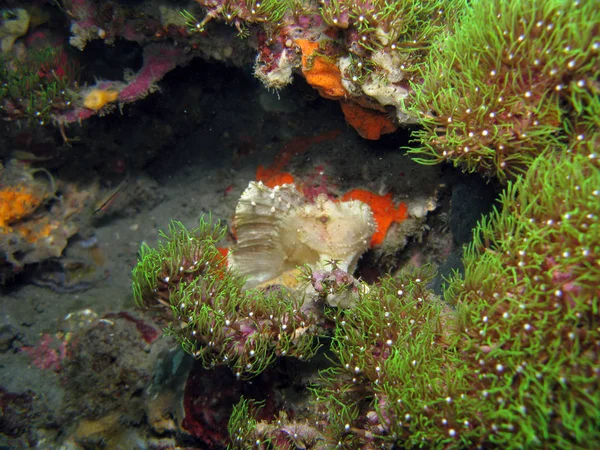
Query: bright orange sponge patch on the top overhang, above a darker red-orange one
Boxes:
[{"xmin": 295, "ymin": 39, "xmax": 346, "ymax": 100}]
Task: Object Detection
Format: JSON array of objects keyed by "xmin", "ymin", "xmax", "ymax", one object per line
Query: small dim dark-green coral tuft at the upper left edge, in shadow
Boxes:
[{"xmin": 0, "ymin": 46, "xmax": 78, "ymax": 125}]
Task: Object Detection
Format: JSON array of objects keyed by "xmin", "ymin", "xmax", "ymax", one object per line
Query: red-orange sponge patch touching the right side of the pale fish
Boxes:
[{"xmin": 342, "ymin": 189, "xmax": 408, "ymax": 247}]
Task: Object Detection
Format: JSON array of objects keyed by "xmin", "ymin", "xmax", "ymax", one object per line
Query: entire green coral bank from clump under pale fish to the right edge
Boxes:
[{"xmin": 134, "ymin": 147, "xmax": 600, "ymax": 449}]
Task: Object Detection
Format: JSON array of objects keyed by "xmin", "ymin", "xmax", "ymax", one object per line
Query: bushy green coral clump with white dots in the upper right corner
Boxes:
[{"xmin": 407, "ymin": 0, "xmax": 600, "ymax": 182}]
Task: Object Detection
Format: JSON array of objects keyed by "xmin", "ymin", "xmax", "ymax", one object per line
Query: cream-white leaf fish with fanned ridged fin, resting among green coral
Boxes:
[{"xmin": 229, "ymin": 182, "xmax": 375, "ymax": 286}]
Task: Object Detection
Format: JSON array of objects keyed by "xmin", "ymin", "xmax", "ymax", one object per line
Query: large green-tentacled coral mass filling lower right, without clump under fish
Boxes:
[{"xmin": 316, "ymin": 153, "xmax": 600, "ymax": 449}]
